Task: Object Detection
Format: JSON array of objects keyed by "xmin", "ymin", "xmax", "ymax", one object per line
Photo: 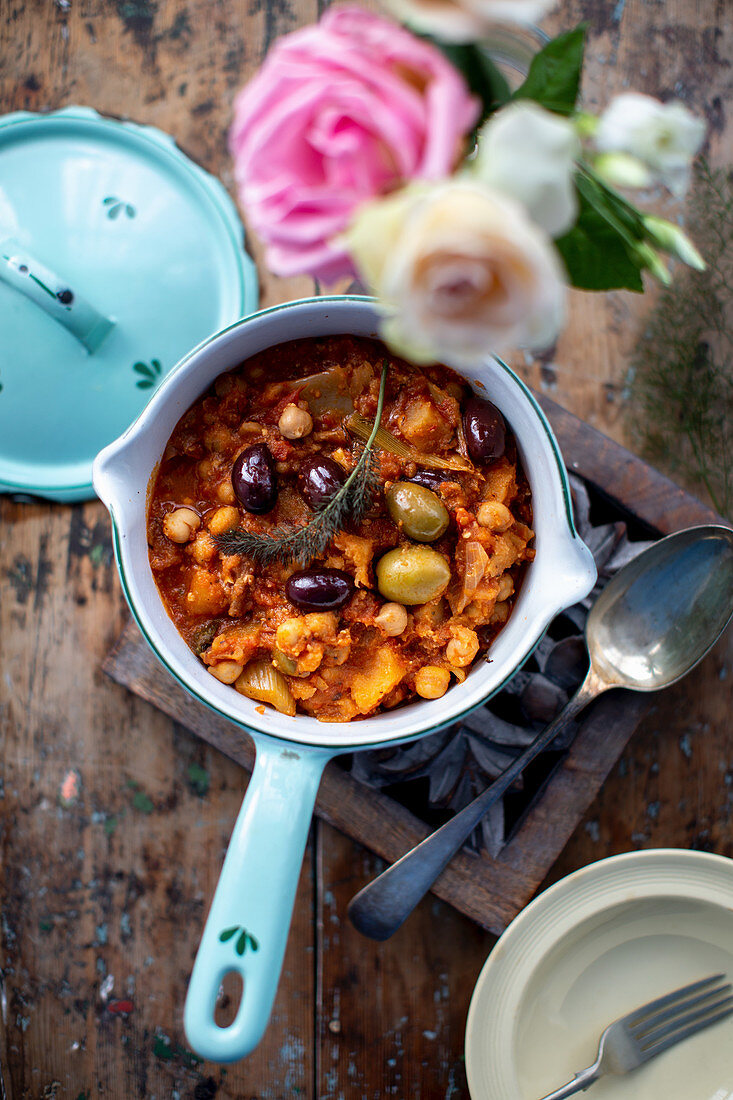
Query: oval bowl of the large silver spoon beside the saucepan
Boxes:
[{"xmin": 586, "ymin": 526, "xmax": 733, "ymax": 691}]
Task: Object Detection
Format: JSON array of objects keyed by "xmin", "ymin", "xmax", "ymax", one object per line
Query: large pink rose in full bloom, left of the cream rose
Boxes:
[{"xmin": 229, "ymin": 6, "xmax": 479, "ymax": 283}]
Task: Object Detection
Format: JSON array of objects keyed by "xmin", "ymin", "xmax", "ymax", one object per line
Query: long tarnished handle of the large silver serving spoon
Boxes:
[{"xmin": 349, "ymin": 668, "xmax": 611, "ymax": 939}]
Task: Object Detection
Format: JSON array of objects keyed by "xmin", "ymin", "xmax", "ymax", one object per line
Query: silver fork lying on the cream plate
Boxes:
[{"xmin": 541, "ymin": 974, "xmax": 733, "ymax": 1100}]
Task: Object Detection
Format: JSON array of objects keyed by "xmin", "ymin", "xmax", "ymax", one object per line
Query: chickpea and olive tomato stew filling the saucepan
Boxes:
[{"xmin": 147, "ymin": 336, "xmax": 535, "ymax": 722}]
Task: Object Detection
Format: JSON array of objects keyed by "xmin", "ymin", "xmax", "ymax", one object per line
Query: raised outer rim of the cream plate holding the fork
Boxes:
[{"xmin": 464, "ymin": 848, "xmax": 733, "ymax": 1100}]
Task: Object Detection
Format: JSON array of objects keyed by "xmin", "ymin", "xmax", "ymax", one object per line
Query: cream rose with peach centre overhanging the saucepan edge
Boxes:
[{"xmin": 346, "ymin": 178, "xmax": 566, "ymax": 365}]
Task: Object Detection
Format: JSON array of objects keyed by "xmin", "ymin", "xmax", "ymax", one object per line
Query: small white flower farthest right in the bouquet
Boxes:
[{"xmin": 595, "ymin": 92, "xmax": 705, "ymax": 195}]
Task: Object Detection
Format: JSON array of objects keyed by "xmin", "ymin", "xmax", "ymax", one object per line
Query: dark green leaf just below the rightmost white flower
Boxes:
[{"xmin": 555, "ymin": 174, "xmax": 644, "ymax": 292}]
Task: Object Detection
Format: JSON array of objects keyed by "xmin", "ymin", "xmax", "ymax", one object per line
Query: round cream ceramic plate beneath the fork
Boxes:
[{"xmin": 466, "ymin": 849, "xmax": 733, "ymax": 1100}]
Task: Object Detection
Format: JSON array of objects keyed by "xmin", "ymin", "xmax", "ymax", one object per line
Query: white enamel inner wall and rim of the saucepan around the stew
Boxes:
[{"xmin": 94, "ymin": 296, "xmax": 595, "ymax": 751}]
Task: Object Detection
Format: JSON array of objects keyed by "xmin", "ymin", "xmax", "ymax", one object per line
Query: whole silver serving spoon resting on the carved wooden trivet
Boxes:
[{"xmin": 349, "ymin": 526, "xmax": 733, "ymax": 939}]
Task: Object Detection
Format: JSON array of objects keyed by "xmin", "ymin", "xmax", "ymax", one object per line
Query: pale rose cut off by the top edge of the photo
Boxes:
[{"xmin": 384, "ymin": 0, "xmax": 557, "ymax": 42}]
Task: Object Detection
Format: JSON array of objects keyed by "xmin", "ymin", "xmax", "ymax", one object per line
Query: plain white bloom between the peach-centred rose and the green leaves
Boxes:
[{"xmin": 474, "ymin": 101, "xmax": 580, "ymax": 237}]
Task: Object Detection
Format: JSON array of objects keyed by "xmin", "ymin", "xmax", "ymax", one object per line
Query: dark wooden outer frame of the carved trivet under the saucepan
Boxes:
[{"xmin": 103, "ymin": 396, "xmax": 725, "ymax": 934}]
